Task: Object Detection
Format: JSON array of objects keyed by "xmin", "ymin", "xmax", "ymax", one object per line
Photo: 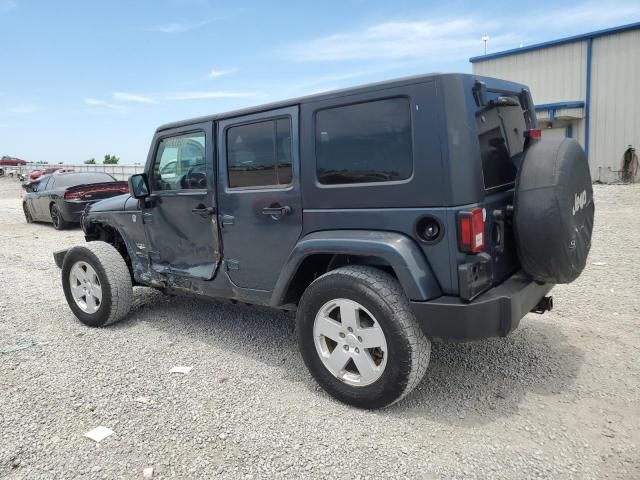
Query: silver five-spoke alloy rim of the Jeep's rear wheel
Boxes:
[{"xmin": 313, "ymin": 298, "xmax": 388, "ymax": 387}]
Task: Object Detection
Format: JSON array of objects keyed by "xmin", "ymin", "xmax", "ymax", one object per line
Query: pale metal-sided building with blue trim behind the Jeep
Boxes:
[{"xmin": 470, "ymin": 22, "xmax": 640, "ymax": 182}]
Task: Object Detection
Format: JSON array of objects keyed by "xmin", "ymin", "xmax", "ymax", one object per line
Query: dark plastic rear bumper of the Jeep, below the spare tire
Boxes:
[{"xmin": 411, "ymin": 272, "xmax": 554, "ymax": 340}]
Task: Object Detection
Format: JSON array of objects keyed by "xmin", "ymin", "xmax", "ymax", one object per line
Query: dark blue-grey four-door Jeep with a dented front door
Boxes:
[{"xmin": 55, "ymin": 74, "xmax": 594, "ymax": 408}]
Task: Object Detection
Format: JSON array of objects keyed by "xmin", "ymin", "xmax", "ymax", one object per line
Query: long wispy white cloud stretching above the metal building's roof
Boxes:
[{"xmin": 283, "ymin": 0, "xmax": 640, "ymax": 64}]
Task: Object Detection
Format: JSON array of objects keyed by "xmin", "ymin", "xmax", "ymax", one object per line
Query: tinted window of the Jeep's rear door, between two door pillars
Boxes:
[{"xmin": 226, "ymin": 117, "xmax": 293, "ymax": 188}]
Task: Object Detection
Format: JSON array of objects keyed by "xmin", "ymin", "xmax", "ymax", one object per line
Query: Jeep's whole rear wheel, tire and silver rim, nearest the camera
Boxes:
[{"xmin": 297, "ymin": 266, "xmax": 431, "ymax": 409}]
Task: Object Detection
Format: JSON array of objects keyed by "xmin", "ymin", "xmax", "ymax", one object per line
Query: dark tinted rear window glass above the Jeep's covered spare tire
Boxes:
[{"xmin": 477, "ymin": 96, "xmax": 527, "ymax": 190}]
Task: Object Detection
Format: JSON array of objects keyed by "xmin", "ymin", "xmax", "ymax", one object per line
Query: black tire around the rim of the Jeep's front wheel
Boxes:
[{"xmin": 62, "ymin": 242, "xmax": 133, "ymax": 327}]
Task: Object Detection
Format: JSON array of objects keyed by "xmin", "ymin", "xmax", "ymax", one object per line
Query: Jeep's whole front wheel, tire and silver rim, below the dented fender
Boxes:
[{"xmin": 62, "ymin": 242, "xmax": 133, "ymax": 327}]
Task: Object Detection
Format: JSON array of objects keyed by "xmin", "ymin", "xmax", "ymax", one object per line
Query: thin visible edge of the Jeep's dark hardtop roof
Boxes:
[{"xmin": 156, "ymin": 73, "xmax": 478, "ymax": 132}]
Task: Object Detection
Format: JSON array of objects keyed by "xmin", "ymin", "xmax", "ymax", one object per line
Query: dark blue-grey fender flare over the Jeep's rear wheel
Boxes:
[{"xmin": 270, "ymin": 230, "xmax": 442, "ymax": 307}]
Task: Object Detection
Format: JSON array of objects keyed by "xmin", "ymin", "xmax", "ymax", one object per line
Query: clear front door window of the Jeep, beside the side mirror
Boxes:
[{"xmin": 151, "ymin": 132, "xmax": 207, "ymax": 191}]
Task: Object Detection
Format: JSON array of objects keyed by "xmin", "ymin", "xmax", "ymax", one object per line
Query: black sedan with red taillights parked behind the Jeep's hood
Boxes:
[{"xmin": 22, "ymin": 172, "xmax": 128, "ymax": 230}]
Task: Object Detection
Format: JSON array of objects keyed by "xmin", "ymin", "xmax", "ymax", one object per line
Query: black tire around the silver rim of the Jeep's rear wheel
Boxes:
[{"xmin": 296, "ymin": 265, "xmax": 431, "ymax": 409}]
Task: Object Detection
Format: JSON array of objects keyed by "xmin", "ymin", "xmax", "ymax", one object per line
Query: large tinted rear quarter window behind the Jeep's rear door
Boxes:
[{"xmin": 315, "ymin": 98, "xmax": 413, "ymax": 185}]
